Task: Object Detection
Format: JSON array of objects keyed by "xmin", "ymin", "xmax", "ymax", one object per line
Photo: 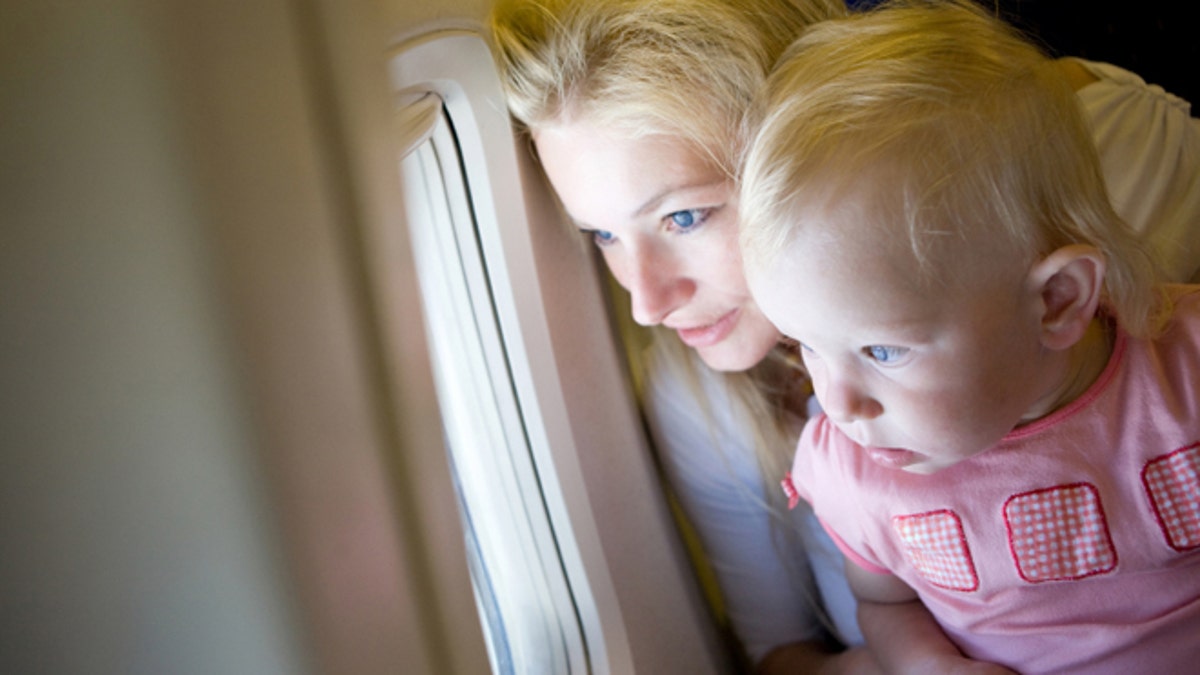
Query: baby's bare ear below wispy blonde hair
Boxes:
[{"xmin": 1028, "ymin": 244, "xmax": 1105, "ymax": 350}]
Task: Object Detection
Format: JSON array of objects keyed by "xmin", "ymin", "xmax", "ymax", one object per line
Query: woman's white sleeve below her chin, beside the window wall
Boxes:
[{"xmin": 646, "ymin": 355, "xmax": 857, "ymax": 663}]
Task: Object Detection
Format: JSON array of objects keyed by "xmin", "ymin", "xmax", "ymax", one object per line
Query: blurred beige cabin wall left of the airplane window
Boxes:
[{"xmin": 0, "ymin": 0, "xmax": 487, "ymax": 674}]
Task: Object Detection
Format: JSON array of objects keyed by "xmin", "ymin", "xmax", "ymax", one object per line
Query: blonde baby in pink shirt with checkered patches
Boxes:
[{"xmin": 740, "ymin": 1, "xmax": 1200, "ymax": 674}]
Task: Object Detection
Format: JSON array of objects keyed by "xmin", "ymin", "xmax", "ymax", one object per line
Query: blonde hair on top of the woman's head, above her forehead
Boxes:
[{"xmin": 488, "ymin": 0, "xmax": 845, "ymax": 177}]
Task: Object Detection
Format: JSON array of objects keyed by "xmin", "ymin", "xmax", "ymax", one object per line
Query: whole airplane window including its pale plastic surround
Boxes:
[{"xmin": 378, "ymin": 31, "xmax": 725, "ymax": 673}]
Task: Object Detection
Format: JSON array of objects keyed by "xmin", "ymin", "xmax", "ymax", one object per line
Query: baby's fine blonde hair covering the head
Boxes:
[{"xmin": 740, "ymin": 0, "xmax": 1160, "ymax": 335}]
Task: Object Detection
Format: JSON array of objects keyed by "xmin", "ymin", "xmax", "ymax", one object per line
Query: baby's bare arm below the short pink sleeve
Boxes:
[{"xmin": 846, "ymin": 560, "xmax": 1012, "ymax": 675}]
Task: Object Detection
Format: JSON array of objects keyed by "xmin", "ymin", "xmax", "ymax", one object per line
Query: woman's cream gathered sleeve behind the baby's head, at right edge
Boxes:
[{"xmin": 1074, "ymin": 59, "xmax": 1200, "ymax": 282}]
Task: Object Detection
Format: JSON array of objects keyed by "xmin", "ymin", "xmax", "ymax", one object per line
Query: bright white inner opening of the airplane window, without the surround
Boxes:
[{"xmin": 402, "ymin": 110, "xmax": 586, "ymax": 673}]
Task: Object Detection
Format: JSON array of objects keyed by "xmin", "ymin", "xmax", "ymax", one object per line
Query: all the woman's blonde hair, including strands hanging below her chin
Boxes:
[{"xmin": 488, "ymin": 0, "xmax": 846, "ymax": 638}]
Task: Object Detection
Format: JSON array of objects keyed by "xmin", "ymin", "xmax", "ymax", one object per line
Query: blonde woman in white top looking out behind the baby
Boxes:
[{"xmin": 491, "ymin": 0, "xmax": 1200, "ymax": 673}]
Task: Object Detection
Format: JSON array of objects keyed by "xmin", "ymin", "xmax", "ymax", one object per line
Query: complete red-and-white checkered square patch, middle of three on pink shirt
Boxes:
[{"xmin": 1004, "ymin": 483, "xmax": 1117, "ymax": 583}]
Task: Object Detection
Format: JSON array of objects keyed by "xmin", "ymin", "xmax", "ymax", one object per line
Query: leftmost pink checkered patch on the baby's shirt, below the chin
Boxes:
[{"xmin": 892, "ymin": 510, "xmax": 979, "ymax": 591}]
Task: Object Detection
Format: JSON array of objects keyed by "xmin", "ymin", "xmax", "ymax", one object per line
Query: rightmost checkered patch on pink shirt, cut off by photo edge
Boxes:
[{"xmin": 1141, "ymin": 443, "xmax": 1200, "ymax": 551}]
